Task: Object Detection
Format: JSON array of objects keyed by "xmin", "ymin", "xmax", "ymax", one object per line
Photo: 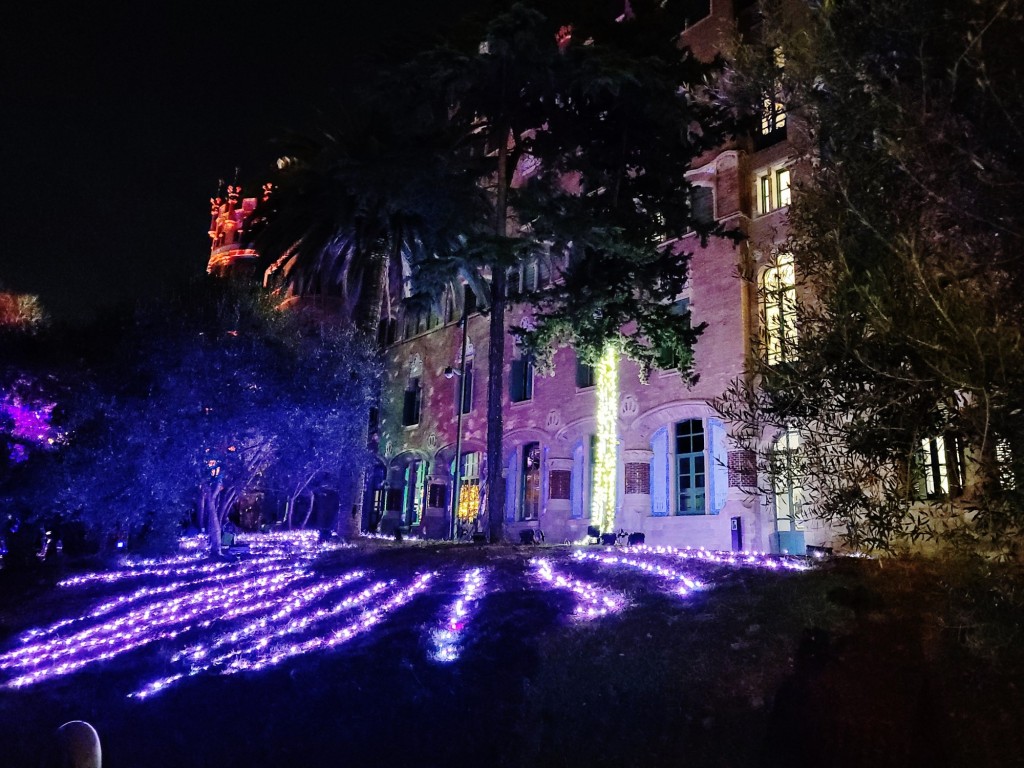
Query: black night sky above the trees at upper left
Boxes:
[{"xmin": 0, "ymin": 0, "xmax": 479, "ymax": 317}]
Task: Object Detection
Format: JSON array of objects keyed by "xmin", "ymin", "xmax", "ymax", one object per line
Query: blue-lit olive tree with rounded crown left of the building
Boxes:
[{"xmin": 11, "ymin": 279, "xmax": 380, "ymax": 553}]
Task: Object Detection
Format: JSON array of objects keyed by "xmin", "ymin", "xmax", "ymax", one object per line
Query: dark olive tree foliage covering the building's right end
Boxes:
[{"xmin": 716, "ymin": 0, "xmax": 1024, "ymax": 557}]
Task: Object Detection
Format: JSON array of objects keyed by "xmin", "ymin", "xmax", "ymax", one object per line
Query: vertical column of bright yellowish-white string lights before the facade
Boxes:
[{"xmin": 590, "ymin": 344, "xmax": 618, "ymax": 532}]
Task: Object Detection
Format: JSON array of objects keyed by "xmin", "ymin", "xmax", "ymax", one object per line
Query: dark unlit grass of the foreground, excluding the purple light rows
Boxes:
[{"xmin": 0, "ymin": 544, "xmax": 1024, "ymax": 768}]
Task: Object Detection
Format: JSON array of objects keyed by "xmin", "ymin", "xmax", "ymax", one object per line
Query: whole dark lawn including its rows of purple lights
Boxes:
[{"xmin": 0, "ymin": 539, "xmax": 1024, "ymax": 768}]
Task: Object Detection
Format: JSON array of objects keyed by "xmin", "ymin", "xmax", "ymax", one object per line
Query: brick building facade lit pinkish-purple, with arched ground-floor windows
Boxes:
[{"xmin": 365, "ymin": 0, "xmax": 831, "ymax": 554}]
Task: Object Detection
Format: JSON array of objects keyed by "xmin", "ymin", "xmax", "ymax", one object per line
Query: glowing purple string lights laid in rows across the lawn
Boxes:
[{"xmin": 0, "ymin": 531, "xmax": 811, "ymax": 698}]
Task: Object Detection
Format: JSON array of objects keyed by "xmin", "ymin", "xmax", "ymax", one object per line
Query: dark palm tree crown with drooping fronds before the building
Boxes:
[{"xmin": 247, "ymin": 99, "xmax": 484, "ymax": 536}]
